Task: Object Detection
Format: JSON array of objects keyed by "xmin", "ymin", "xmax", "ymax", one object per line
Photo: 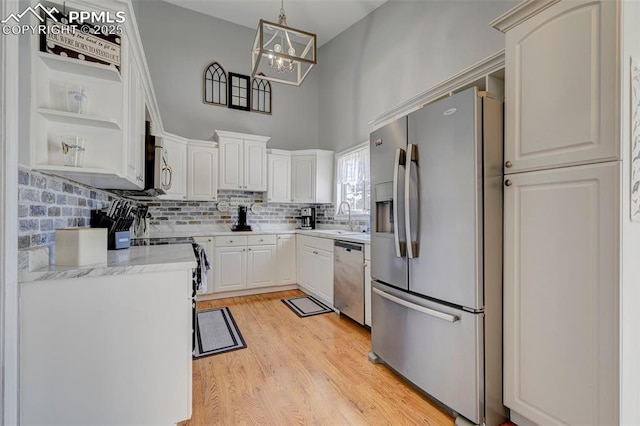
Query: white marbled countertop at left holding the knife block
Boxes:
[{"xmin": 18, "ymin": 244, "xmax": 197, "ymax": 282}]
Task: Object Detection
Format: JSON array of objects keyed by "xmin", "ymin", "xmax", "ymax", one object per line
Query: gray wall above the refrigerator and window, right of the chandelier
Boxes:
[{"xmin": 318, "ymin": 0, "xmax": 519, "ymax": 151}]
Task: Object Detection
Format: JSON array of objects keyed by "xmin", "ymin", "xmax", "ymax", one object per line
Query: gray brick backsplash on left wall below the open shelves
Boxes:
[{"xmin": 18, "ymin": 169, "xmax": 119, "ymax": 250}]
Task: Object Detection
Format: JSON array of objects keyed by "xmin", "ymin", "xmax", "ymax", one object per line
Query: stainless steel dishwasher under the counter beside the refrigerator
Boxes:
[{"xmin": 333, "ymin": 240, "xmax": 364, "ymax": 324}]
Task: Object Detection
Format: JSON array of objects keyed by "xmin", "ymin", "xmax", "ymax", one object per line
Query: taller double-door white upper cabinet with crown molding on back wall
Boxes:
[{"xmin": 216, "ymin": 130, "xmax": 270, "ymax": 191}]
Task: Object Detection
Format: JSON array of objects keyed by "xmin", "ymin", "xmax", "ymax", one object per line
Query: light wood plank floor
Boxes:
[{"xmin": 183, "ymin": 290, "xmax": 454, "ymax": 426}]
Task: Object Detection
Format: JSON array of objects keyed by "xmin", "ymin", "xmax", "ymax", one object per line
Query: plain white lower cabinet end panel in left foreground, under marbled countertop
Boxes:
[{"xmin": 20, "ymin": 269, "xmax": 192, "ymax": 425}]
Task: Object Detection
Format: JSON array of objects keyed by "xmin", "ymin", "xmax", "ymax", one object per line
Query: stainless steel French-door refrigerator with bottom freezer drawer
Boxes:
[{"xmin": 370, "ymin": 87, "xmax": 506, "ymax": 425}]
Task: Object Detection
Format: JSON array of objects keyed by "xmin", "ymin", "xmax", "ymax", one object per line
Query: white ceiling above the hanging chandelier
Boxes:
[{"xmin": 165, "ymin": 0, "xmax": 387, "ymax": 46}]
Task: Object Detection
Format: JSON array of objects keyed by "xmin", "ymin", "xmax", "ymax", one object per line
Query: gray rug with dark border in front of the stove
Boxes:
[{"xmin": 193, "ymin": 307, "xmax": 247, "ymax": 358}]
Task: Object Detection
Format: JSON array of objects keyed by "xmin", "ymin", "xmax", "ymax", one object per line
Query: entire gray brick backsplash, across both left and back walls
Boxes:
[{"xmin": 18, "ymin": 169, "xmax": 368, "ymax": 250}]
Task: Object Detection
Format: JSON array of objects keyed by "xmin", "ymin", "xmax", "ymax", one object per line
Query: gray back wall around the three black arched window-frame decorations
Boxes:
[{"xmin": 135, "ymin": 0, "xmax": 319, "ymax": 149}]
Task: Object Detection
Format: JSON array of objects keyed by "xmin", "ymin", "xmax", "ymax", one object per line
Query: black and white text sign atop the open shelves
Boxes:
[{"xmin": 40, "ymin": 8, "xmax": 122, "ymax": 71}]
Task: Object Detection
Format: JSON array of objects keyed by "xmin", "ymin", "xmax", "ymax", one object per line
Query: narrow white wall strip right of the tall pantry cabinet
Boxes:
[{"xmin": 620, "ymin": 0, "xmax": 640, "ymax": 425}]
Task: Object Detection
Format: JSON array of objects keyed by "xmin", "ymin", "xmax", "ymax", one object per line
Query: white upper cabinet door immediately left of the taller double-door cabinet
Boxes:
[{"xmin": 187, "ymin": 140, "xmax": 218, "ymax": 201}]
